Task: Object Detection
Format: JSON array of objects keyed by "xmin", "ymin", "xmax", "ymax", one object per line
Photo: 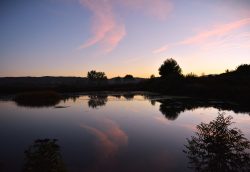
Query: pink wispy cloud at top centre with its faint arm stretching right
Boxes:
[{"xmin": 79, "ymin": 0, "xmax": 171, "ymax": 52}]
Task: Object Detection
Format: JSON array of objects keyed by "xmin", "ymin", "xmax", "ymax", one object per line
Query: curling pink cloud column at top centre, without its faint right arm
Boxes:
[{"xmin": 80, "ymin": 0, "xmax": 126, "ymax": 49}]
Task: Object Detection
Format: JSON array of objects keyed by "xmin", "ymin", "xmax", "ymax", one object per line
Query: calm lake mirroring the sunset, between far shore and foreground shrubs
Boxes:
[{"xmin": 0, "ymin": 93, "xmax": 250, "ymax": 172}]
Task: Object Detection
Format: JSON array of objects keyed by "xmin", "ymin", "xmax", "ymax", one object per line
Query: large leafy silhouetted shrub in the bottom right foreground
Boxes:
[{"xmin": 184, "ymin": 114, "xmax": 250, "ymax": 172}]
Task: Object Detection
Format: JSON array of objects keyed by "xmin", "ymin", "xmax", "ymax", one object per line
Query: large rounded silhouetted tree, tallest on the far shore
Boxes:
[{"xmin": 159, "ymin": 58, "xmax": 182, "ymax": 78}]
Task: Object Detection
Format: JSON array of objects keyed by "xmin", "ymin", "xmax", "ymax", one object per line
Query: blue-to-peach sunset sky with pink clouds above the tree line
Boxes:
[{"xmin": 0, "ymin": 0, "xmax": 250, "ymax": 78}]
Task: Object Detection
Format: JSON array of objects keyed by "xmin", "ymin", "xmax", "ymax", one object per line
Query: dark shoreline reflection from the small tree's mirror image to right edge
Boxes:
[{"xmin": 68, "ymin": 92, "xmax": 250, "ymax": 120}]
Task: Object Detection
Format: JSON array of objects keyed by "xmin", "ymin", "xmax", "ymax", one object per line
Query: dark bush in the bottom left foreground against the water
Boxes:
[{"xmin": 23, "ymin": 139, "xmax": 67, "ymax": 172}]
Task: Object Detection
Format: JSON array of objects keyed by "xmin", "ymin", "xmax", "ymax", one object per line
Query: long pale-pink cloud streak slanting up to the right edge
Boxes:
[{"xmin": 153, "ymin": 18, "xmax": 250, "ymax": 53}]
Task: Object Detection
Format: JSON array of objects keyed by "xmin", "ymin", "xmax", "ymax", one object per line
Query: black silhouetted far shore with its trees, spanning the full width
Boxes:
[{"xmin": 0, "ymin": 59, "xmax": 250, "ymax": 104}]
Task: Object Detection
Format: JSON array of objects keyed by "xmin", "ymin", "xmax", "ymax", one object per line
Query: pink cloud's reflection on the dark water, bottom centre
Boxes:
[{"xmin": 81, "ymin": 118, "xmax": 128, "ymax": 171}]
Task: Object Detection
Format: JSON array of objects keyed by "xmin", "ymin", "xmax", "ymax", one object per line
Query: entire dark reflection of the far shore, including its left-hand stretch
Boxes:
[{"xmin": 10, "ymin": 92, "xmax": 250, "ymax": 120}]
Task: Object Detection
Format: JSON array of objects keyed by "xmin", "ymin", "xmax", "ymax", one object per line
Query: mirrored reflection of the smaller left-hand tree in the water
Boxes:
[{"xmin": 88, "ymin": 95, "xmax": 108, "ymax": 109}]
